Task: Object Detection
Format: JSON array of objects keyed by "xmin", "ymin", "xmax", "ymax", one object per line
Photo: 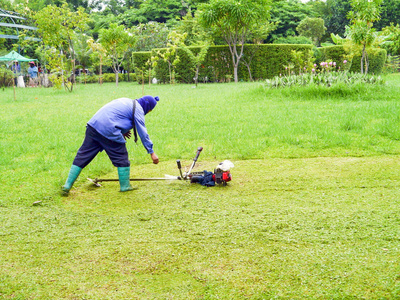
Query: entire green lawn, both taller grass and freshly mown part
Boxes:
[{"xmin": 0, "ymin": 75, "xmax": 400, "ymax": 299}]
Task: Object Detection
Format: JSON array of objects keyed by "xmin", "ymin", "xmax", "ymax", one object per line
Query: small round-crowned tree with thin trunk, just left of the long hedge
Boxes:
[{"xmin": 99, "ymin": 24, "xmax": 136, "ymax": 86}]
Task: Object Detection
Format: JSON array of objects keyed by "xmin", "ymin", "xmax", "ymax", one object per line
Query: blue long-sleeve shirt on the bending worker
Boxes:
[{"xmin": 88, "ymin": 98, "xmax": 154, "ymax": 154}]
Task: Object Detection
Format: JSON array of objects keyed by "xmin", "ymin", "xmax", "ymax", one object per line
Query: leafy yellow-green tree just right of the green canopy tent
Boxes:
[{"xmin": 34, "ymin": 3, "xmax": 88, "ymax": 91}]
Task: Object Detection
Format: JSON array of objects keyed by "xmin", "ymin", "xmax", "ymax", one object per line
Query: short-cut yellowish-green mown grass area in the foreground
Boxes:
[{"xmin": 0, "ymin": 156, "xmax": 400, "ymax": 299}]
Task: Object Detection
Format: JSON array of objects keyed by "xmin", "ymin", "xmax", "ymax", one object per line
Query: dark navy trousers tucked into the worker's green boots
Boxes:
[{"xmin": 72, "ymin": 125, "xmax": 130, "ymax": 169}]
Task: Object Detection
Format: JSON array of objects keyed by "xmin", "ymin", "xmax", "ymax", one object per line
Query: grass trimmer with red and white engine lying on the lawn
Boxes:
[{"xmin": 88, "ymin": 147, "xmax": 234, "ymax": 187}]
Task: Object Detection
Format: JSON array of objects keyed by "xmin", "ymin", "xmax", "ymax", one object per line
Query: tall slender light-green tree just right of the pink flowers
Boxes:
[{"xmin": 346, "ymin": 0, "xmax": 383, "ymax": 74}]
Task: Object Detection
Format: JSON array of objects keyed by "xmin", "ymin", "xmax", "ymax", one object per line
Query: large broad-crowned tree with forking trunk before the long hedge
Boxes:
[{"xmin": 200, "ymin": 0, "xmax": 269, "ymax": 82}]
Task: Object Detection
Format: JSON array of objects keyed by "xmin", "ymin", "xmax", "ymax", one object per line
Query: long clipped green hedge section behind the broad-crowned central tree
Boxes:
[{"xmin": 133, "ymin": 44, "xmax": 313, "ymax": 83}]
